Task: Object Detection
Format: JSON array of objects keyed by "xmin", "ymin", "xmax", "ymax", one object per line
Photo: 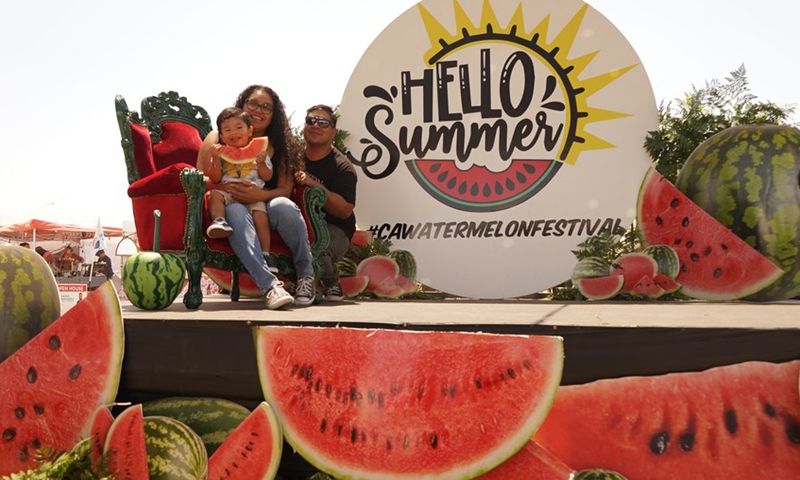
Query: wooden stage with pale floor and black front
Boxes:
[{"xmin": 117, "ymin": 295, "xmax": 800, "ymax": 407}]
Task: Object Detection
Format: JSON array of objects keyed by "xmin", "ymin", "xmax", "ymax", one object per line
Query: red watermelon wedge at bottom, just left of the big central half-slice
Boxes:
[{"xmin": 208, "ymin": 402, "xmax": 283, "ymax": 480}]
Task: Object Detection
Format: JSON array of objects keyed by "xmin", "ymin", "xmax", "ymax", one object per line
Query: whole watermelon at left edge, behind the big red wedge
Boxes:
[{"xmin": 0, "ymin": 245, "xmax": 61, "ymax": 362}]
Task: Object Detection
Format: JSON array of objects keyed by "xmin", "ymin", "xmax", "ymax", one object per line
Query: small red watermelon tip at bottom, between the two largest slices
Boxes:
[{"xmin": 477, "ymin": 440, "xmax": 573, "ymax": 480}]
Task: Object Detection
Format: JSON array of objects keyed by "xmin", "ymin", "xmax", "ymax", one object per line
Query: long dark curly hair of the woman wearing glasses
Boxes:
[{"xmin": 234, "ymin": 85, "xmax": 303, "ymax": 179}]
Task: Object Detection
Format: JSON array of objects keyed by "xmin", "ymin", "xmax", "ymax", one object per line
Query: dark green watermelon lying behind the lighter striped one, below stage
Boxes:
[{"xmin": 142, "ymin": 397, "xmax": 250, "ymax": 455}]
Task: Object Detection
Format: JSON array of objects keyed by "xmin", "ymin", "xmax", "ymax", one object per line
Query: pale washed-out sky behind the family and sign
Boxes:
[{"xmin": 0, "ymin": 0, "xmax": 800, "ymax": 230}]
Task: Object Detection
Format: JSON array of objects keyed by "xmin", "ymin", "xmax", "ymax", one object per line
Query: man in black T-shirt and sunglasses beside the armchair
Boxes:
[{"xmin": 297, "ymin": 105, "xmax": 357, "ymax": 302}]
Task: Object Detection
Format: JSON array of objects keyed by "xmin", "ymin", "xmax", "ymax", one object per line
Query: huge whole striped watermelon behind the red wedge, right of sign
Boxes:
[{"xmin": 675, "ymin": 125, "xmax": 800, "ymax": 301}]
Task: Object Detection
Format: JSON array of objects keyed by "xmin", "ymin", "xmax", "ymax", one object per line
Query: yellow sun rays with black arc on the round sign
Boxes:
[{"xmin": 418, "ymin": 0, "xmax": 638, "ymax": 165}]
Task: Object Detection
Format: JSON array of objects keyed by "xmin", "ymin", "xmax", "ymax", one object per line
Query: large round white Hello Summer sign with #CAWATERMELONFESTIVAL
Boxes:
[{"xmin": 339, "ymin": 0, "xmax": 658, "ymax": 298}]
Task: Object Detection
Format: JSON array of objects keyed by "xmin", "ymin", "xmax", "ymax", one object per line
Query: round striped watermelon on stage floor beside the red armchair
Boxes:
[{"xmin": 122, "ymin": 252, "xmax": 186, "ymax": 310}]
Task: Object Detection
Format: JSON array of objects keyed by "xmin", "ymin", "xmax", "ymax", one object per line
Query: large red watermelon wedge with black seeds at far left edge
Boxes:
[{"xmin": 0, "ymin": 282, "xmax": 124, "ymax": 475}]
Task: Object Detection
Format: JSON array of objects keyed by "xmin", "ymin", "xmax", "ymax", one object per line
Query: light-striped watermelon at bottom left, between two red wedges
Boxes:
[{"xmin": 144, "ymin": 415, "xmax": 208, "ymax": 480}]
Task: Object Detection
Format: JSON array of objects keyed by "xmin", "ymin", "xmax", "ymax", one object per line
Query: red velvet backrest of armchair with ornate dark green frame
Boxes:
[{"xmin": 115, "ymin": 92, "xmax": 211, "ymax": 184}]
